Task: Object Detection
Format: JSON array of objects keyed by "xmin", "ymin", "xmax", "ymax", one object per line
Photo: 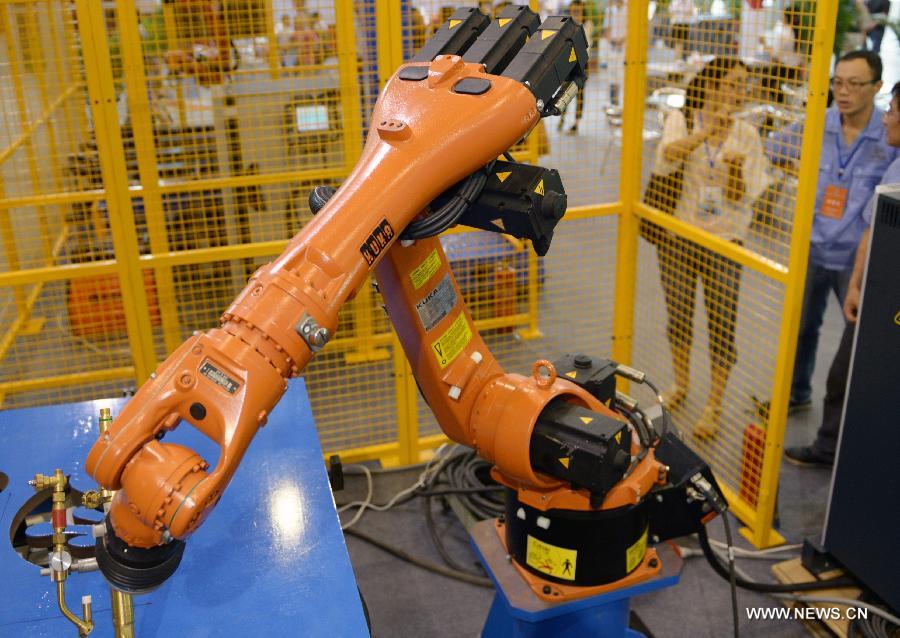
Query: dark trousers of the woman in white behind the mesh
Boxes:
[{"xmin": 658, "ymin": 235, "xmax": 743, "ymax": 371}]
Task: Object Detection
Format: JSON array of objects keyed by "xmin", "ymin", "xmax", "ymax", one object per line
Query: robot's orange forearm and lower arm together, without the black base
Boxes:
[{"xmin": 86, "ymin": 6, "xmax": 724, "ymax": 592}]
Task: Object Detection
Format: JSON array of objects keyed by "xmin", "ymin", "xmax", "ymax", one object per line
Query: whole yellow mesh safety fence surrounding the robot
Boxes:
[{"xmin": 0, "ymin": 0, "xmax": 835, "ymax": 546}]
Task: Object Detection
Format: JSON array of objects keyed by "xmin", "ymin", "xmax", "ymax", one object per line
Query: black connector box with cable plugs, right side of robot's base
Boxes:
[{"xmin": 647, "ymin": 432, "xmax": 727, "ymax": 543}]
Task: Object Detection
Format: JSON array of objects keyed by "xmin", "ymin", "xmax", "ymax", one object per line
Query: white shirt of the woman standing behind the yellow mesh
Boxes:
[{"xmin": 654, "ymin": 111, "xmax": 769, "ymax": 241}]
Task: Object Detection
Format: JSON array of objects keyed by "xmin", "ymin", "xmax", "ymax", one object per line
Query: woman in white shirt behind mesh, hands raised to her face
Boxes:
[{"xmin": 654, "ymin": 57, "xmax": 768, "ymax": 439}]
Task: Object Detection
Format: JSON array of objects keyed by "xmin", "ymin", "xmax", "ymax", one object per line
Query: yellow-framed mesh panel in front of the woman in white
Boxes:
[{"xmin": 633, "ymin": 3, "xmax": 814, "ymax": 509}]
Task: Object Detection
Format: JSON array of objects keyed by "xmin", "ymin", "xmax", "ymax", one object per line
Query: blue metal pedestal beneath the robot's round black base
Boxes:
[{"xmin": 471, "ymin": 520, "xmax": 683, "ymax": 638}]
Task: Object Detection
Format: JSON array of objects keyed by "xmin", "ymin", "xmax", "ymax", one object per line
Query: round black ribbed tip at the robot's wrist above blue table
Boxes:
[{"xmin": 95, "ymin": 515, "xmax": 184, "ymax": 594}]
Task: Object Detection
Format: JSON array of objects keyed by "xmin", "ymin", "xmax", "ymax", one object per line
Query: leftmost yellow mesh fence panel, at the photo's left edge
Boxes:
[{"xmin": 0, "ymin": 2, "xmax": 132, "ymax": 408}]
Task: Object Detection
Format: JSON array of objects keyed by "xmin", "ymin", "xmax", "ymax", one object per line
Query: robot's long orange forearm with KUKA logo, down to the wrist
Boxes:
[{"xmin": 86, "ymin": 9, "xmax": 586, "ymax": 591}]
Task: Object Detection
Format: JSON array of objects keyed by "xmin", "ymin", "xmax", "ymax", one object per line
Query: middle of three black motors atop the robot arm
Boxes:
[{"xmin": 463, "ymin": 4, "xmax": 541, "ymax": 75}]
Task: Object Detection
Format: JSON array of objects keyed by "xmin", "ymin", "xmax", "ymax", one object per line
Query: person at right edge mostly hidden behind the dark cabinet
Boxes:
[{"xmin": 784, "ymin": 82, "xmax": 900, "ymax": 467}]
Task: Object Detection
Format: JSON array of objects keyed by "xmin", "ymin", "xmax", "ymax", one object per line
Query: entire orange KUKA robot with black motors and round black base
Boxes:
[{"xmin": 79, "ymin": 6, "xmax": 725, "ymax": 636}]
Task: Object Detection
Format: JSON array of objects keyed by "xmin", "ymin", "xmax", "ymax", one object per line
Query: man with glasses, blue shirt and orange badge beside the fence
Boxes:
[{"xmin": 767, "ymin": 51, "xmax": 898, "ymax": 411}]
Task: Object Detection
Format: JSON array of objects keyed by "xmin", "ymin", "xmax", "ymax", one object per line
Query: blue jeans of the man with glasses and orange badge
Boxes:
[{"xmin": 791, "ymin": 261, "xmax": 853, "ymax": 403}]
